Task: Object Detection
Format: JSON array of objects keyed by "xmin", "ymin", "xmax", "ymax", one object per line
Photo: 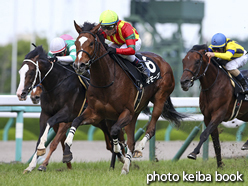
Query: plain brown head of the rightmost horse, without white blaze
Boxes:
[{"xmin": 180, "ymin": 45, "xmax": 209, "ymax": 91}]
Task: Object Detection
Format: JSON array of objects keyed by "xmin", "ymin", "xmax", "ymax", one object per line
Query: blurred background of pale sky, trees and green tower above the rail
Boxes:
[{"xmin": 0, "ymin": 0, "xmax": 248, "ymax": 97}]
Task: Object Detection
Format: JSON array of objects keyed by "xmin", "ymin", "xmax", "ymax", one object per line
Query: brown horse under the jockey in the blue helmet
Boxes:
[{"xmin": 180, "ymin": 45, "xmax": 248, "ymax": 167}]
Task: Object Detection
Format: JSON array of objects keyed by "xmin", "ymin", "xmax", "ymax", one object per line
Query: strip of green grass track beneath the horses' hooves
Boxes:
[{"xmin": 0, "ymin": 158, "xmax": 248, "ymax": 186}]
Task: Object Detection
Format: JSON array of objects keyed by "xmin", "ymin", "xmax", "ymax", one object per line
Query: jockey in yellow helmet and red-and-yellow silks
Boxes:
[{"xmin": 99, "ymin": 10, "xmax": 150, "ymax": 77}]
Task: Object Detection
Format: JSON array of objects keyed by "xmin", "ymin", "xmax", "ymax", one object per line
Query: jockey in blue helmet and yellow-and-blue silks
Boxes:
[{"xmin": 206, "ymin": 33, "xmax": 248, "ymax": 93}]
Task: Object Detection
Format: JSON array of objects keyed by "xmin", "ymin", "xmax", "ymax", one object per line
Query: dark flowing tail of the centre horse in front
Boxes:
[{"xmin": 161, "ymin": 96, "xmax": 187, "ymax": 128}]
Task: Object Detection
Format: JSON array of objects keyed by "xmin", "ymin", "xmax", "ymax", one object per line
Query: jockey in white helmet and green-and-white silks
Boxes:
[{"xmin": 48, "ymin": 36, "xmax": 76, "ymax": 65}]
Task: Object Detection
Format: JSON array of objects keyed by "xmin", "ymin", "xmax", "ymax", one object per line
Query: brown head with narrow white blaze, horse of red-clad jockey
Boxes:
[{"xmin": 73, "ymin": 21, "xmax": 100, "ymax": 73}]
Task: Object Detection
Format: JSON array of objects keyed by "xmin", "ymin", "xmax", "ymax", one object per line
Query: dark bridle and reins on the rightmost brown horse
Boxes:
[{"xmin": 183, "ymin": 50, "xmax": 219, "ymax": 91}]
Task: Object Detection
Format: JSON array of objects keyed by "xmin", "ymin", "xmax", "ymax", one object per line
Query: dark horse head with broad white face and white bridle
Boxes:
[{"xmin": 16, "ymin": 46, "xmax": 48, "ymax": 101}]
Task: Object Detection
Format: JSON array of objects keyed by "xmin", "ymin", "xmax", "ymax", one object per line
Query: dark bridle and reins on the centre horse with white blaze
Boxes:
[{"xmin": 77, "ymin": 31, "xmax": 115, "ymax": 88}]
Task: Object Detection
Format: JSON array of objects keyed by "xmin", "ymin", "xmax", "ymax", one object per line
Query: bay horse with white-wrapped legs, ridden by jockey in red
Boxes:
[{"xmin": 59, "ymin": 22, "xmax": 183, "ymax": 174}]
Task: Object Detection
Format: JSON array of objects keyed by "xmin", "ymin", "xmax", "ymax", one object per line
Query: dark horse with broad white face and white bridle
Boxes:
[{"xmin": 17, "ymin": 46, "xmax": 123, "ymax": 173}]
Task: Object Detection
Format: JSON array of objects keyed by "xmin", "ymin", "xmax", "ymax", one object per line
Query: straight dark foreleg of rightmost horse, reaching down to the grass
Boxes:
[{"xmin": 211, "ymin": 128, "xmax": 224, "ymax": 167}]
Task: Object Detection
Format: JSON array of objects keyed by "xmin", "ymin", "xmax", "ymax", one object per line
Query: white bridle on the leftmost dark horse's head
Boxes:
[{"xmin": 23, "ymin": 59, "xmax": 54, "ymax": 92}]
